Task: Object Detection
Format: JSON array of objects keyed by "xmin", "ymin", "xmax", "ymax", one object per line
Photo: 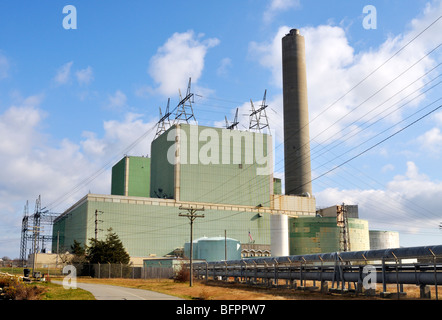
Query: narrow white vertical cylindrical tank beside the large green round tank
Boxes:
[{"xmin": 270, "ymin": 214, "xmax": 289, "ymax": 257}]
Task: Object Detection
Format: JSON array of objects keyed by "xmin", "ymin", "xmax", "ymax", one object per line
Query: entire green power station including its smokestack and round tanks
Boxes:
[{"xmin": 52, "ymin": 29, "xmax": 398, "ymax": 260}]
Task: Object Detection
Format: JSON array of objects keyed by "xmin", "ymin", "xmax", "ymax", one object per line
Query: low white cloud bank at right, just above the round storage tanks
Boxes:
[{"xmin": 315, "ymin": 162, "xmax": 442, "ymax": 238}]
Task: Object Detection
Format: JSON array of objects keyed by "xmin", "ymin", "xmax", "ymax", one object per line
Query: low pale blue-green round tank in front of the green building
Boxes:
[{"xmin": 184, "ymin": 237, "xmax": 241, "ymax": 261}]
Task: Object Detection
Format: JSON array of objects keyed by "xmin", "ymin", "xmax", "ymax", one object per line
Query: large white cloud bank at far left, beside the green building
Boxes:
[{"xmin": 0, "ymin": 96, "xmax": 155, "ymax": 239}]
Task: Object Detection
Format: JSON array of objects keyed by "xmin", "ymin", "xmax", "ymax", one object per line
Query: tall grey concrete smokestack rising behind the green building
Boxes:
[{"xmin": 282, "ymin": 29, "xmax": 312, "ymax": 195}]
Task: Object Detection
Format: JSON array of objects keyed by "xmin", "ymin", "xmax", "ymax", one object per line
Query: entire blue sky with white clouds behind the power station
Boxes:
[{"xmin": 0, "ymin": 0, "xmax": 442, "ymax": 258}]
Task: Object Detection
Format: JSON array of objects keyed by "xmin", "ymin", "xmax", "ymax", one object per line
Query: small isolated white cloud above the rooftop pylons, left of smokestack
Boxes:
[{"xmin": 148, "ymin": 31, "xmax": 219, "ymax": 96}]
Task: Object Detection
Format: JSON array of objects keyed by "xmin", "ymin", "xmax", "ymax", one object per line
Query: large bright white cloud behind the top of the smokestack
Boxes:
[{"xmin": 249, "ymin": 2, "xmax": 442, "ymax": 143}]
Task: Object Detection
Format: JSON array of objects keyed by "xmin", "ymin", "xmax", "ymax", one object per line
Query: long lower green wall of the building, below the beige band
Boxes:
[{"xmin": 53, "ymin": 195, "xmax": 270, "ymax": 257}]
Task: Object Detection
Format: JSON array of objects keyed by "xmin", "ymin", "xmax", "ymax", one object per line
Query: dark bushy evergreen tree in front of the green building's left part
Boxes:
[{"xmin": 86, "ymin": 228, "xmax": 130, "ymax": 264}]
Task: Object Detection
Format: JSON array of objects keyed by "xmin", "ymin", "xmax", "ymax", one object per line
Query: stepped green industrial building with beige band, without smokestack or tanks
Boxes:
[{"xmin": 53, "ymin": 124, "xmax": 315, "ymax": 257}]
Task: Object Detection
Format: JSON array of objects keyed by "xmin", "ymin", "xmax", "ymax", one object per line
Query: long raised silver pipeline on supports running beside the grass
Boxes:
[{"xmin": 193, "ymin": 246, "xmax": 442, "ymax": 299}]
